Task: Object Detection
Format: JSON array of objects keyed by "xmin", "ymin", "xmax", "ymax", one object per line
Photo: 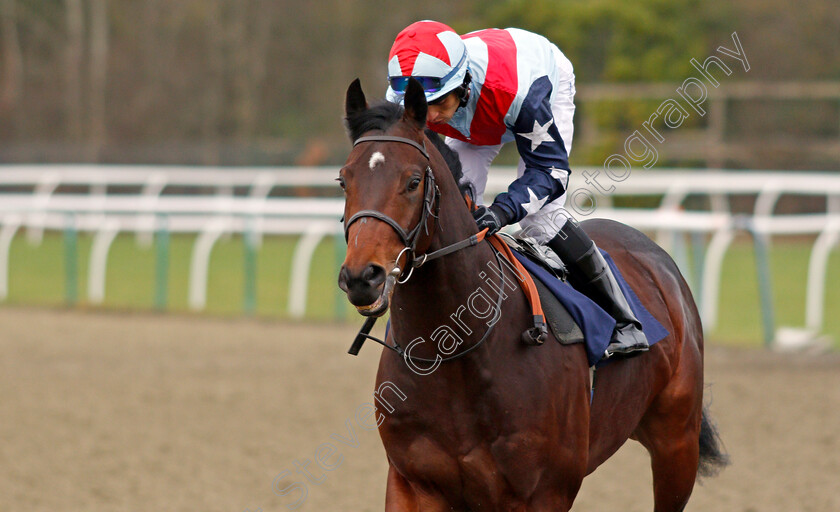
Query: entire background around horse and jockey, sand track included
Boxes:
[{"xmin": 0, "ymin": 0, "xmax": 840, "ymax": 512}]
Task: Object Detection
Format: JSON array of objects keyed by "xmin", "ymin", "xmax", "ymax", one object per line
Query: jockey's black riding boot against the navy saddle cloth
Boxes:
[{"xmin": 546, "ymin": 221, "xmax": 650, "ymax": 357}]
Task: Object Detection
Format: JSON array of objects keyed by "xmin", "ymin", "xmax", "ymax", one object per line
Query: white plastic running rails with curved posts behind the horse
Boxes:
[{"xmin": 0, "ymin": 165, "xmax": 840, "ymax": 344}]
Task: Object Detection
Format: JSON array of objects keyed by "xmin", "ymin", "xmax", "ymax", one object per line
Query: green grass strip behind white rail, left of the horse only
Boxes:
[{"xmin": 7, "ymin": 233, "xmax": 352, "ymax": 319}]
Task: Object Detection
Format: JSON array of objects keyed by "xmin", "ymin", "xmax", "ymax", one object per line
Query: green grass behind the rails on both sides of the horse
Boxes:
[{"xmin": 7, "ymin": 232, "xmax": 840, "ymax": 347}]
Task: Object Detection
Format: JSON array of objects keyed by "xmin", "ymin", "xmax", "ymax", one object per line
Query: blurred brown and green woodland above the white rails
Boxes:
[{"xmin": 0, "ymin": 0, "xmax": 840, "ymax": 170}]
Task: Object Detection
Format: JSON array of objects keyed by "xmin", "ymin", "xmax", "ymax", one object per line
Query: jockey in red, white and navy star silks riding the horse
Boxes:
[{"xmin": 386, "ymin": 21, "xmax": 648, "ymax": 356}]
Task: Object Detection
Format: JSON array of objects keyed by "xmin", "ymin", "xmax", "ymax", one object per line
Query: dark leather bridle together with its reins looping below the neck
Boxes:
[{"xmin": 344, "ymin": 135, "xmax": 504, "ymax": 363}]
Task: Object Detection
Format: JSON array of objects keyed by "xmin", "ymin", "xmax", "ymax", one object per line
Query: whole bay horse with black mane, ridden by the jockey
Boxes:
[{"xmin": 338, "ymin": 80, "xmax": 726, "ymax": 512}]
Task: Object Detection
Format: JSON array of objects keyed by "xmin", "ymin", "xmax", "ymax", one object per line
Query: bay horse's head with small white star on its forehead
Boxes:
[{"xmin": 338, "ymin": 80, "xmax": 445, "ymax": 316}]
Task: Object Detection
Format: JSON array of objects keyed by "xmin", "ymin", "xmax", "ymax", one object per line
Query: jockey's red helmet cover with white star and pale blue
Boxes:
[{"xmin": 387, "ymin": 20, "xmax": 469, "ymax": 103}]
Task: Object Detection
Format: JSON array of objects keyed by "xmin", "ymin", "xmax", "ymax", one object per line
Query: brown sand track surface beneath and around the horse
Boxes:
[{"xmin": 0, "ymin": 308, "xmax": 840, "ymax": 512}]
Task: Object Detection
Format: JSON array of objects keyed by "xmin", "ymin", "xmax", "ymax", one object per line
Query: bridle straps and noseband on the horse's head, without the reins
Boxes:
[{"xmin": 344, "ymin": 135, "xmax": 440, "ymax": 283}]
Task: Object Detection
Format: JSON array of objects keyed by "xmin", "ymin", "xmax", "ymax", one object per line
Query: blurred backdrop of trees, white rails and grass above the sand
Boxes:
[{"xmin": 0, "ymin": 0, "xmax": 840, "ymax": 342}]
